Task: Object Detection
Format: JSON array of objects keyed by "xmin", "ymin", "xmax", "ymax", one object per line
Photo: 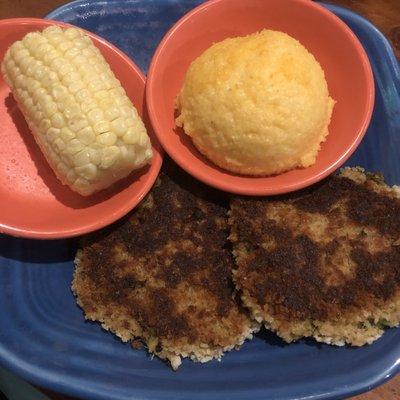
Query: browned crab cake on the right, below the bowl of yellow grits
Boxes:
[{"xmin": 230, "ymin": 168, "xmax": 400, "ymax": 346}]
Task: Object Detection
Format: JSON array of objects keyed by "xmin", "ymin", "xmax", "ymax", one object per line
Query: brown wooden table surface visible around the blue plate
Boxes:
[{"xmin": 0, "ymin": 0, "xmax": 400, "ymax": 400}]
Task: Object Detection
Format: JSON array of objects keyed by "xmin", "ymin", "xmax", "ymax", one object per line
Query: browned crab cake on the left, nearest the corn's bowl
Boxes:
[{"xmin": 72, "ymin": 169, "xmax": 257, "ymax": 369}]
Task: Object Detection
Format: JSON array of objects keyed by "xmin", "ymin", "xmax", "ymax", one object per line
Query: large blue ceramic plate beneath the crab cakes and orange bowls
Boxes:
[{"xmin": 0, "ymin": 0, "xmax": 400, "ymax": 400}]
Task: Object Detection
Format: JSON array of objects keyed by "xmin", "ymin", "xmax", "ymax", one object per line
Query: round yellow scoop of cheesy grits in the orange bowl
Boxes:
[{"xmin": 176, "ymin": 30, "xmax": 334, "ymax": 175}]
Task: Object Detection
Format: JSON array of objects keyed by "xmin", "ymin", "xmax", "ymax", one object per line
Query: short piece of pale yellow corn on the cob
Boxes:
[{"xmin": 1, "ymin": 26, "xmax": 152, "ymax": 196}]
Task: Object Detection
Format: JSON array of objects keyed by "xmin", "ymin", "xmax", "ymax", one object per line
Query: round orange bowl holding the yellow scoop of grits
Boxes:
[{"xmin": 146, "ymin": 0, "xmax": 375, "ymax": 195}]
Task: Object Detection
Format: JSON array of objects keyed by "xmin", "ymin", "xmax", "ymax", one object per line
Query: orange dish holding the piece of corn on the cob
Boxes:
[{"xmin": 0, "ymin": 18, "xmax": 162, "ymax": 239}]
